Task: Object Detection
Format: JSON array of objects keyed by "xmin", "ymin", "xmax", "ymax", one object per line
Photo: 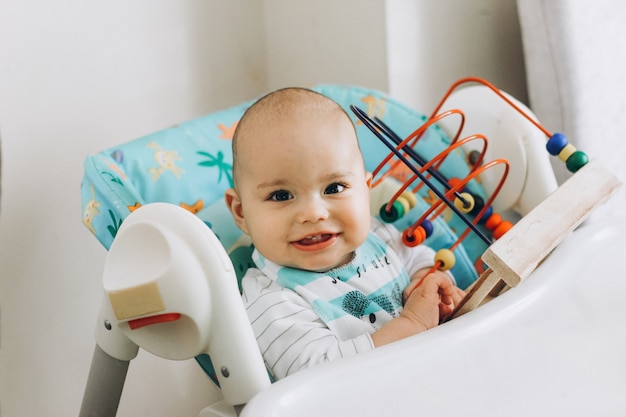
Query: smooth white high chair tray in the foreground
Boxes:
[{"xmin": 242, "ymin": 219, "xmax": 626, "ymax": 417}]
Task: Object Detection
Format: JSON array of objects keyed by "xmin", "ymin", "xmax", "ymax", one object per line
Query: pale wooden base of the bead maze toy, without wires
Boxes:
[{"xmin": 451, "ymin": 161, "xmax": 622, "ymax": 318}]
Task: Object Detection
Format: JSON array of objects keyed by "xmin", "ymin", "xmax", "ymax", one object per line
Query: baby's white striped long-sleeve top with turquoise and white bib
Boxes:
[{"xmin": 242, "ymin": 219, "xmax": 434, "ymax": 378}]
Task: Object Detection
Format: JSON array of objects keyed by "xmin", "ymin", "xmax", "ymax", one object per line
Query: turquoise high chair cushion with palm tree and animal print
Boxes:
[{"xmin": 81, "ymin": 85, "xmax": 485, "ymax": 287}]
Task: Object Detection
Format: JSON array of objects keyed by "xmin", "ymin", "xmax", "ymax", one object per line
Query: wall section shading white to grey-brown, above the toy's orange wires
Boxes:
[{"xmin": 386, "ymin": 0, "xmax": 527, "ymax": 114}]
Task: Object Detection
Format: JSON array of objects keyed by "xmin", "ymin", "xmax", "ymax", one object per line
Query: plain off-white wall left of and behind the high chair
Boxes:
[{"xmin": 0, "ymin": 0, "xmax": 265, "ymax": 417}]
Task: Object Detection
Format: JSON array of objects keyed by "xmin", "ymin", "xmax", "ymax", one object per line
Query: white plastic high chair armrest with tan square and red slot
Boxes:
[{"xmin": 98, "ymin": 203, "xmax": 270, "ymax": 405}]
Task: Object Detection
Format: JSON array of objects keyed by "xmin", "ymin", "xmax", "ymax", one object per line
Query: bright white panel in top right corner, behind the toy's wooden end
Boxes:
[{"xmin": 518, "ymin": 0, "xmax": 626, "ymax": 222}]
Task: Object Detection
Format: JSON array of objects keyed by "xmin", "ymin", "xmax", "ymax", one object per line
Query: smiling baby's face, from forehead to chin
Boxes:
[{"xmin": 230, "ymin": 112, "xmax": 370, "ymax": 271}]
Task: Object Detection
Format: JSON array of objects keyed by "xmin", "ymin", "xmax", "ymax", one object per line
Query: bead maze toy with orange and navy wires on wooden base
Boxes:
[{"xmin": 351, "ymin": 77, "xmax": 621, "ymax": 318}]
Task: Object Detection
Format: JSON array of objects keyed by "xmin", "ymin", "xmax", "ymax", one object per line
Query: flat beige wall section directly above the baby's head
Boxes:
[{"xmin": 264, "ymin": 0, "xmax": 388, "ymax": 91}]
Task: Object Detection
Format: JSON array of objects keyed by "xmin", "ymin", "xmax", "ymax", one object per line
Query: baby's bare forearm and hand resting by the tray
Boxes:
[{"xmin": 372, "ymin": 268, "xmax": 463, "ymax": 347}]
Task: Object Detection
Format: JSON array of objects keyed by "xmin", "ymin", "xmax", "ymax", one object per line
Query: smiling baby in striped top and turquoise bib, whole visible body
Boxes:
[{"xmin": 225, "ymin": 88, "xmax": 464, "ymax": 378}]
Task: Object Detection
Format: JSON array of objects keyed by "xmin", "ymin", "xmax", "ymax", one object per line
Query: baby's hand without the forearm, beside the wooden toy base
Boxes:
[{"xmin": 402, "ymin": 268, "xmax": 465, "ymax": 329}]
